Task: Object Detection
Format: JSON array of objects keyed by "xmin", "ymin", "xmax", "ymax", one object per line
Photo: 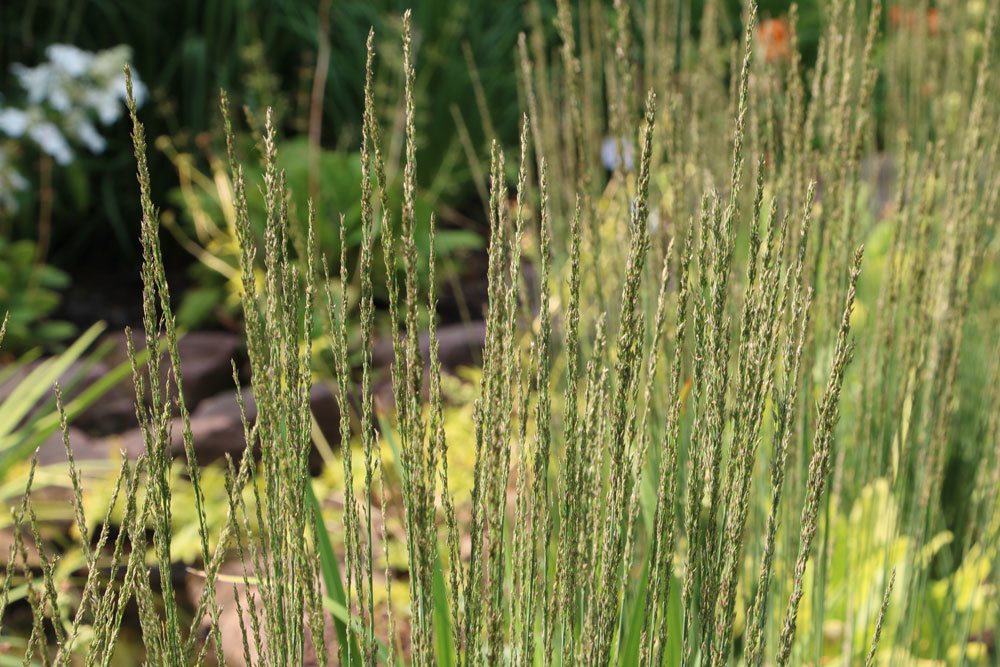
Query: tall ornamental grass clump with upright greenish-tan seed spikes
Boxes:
[{"xmin": 0, "ymin": 0, "xmax": 1000, "ymax": 666}]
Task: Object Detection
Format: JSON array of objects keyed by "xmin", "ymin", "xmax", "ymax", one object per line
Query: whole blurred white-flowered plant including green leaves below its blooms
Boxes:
[{"xmin": 0, "ymin": 44, "xmax": 146, "ymax": 350}]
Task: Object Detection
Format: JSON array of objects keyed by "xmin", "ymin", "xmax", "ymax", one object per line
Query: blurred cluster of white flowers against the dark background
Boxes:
[{"xmin": 0, "ymin": 44, "xmax": 147, "ymax": 211}]
